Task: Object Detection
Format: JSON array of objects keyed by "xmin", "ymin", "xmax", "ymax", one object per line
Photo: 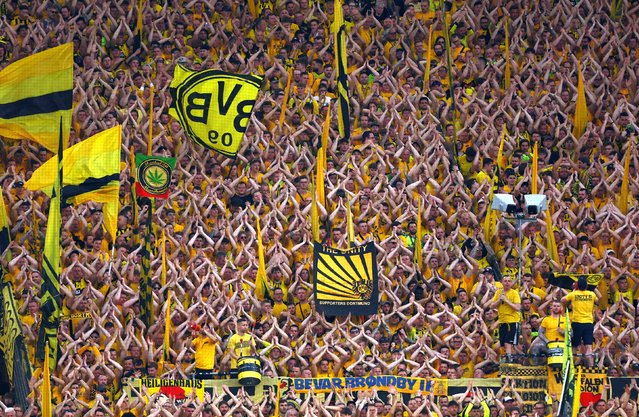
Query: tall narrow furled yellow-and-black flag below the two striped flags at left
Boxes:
[{"xmin": 34, "ymin": 118, "xmax": 64, "ymax": 372}]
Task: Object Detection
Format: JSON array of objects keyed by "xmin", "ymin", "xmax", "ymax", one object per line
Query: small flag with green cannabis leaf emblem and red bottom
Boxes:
[{"xmin": 135, "ymin": 153, "xmax": 175, "ymax": 198}]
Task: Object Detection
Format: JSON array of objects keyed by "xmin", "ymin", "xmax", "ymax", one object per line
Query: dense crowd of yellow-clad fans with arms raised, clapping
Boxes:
[{"xmin": 0, "ymin": 0, "xmax": 639, "ymax": 417}]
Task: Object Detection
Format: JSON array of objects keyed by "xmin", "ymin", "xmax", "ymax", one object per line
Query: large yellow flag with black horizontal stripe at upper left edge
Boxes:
[{"xmin": 0, "ymin": 43, "xmax": 73, "ymax": 153}]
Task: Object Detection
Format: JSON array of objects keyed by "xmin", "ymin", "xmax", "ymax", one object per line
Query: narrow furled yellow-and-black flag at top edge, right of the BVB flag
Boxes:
[{"xmin": 331, "ymin": 0, "xmax": 351, "ymax": 139}]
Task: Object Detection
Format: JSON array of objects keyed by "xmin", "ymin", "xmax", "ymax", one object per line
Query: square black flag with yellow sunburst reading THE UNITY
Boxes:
[{"xmin": 313, "ymin": 242, "xmax": 379, "ymax": 316}]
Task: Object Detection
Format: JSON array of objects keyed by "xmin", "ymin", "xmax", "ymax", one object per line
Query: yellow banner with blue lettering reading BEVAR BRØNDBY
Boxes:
[{"xmin": 279, "ymin": 375, "xmax": 448, "ymax": 397}]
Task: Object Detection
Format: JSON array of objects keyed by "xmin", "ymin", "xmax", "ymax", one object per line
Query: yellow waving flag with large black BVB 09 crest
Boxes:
[{"xmin": 169, "ymin": 65, "xmax": 264, "ymax": 157}]
